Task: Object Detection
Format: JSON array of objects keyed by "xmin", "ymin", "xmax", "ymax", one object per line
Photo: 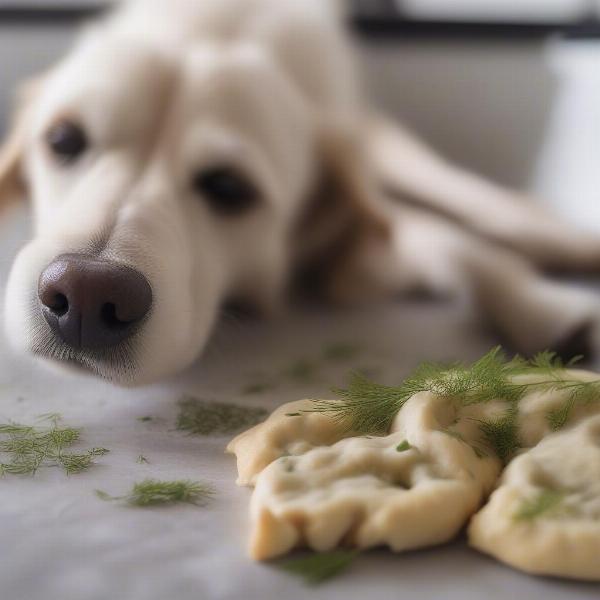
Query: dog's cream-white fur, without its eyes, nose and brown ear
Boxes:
[{"xmin": 0, "ymin": 0, "xmax": 600, "ymax": 384}]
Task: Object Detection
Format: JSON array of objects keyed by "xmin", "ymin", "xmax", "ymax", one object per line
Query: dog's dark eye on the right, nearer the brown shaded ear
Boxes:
[{"xmin": 192, "ymin": 167, "xmax": 259, "ymax": 215}]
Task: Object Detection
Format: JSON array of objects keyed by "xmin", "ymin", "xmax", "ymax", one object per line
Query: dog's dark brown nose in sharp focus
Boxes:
[{"xmin": 38, "ymin": 254, "xmax": 152, "ymax": 349}]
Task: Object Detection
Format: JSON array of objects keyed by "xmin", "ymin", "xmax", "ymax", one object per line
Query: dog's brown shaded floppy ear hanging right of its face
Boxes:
[{"xmin": 295, "ymin": 122, "xmax": 392, "ymax": 303}]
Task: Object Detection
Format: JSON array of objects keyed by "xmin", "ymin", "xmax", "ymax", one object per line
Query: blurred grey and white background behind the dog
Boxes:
[{"xmin": 0, "ymin": 0, "xmax": 600, "ymax": 229}]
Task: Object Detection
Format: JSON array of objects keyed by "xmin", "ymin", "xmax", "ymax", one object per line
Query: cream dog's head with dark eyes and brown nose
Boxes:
[{"xmin": 0, "ymin": 23, "xmax": 392, "ymax": 384}]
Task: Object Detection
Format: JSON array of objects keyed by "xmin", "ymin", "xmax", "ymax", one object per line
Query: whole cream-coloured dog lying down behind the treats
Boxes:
[{"xmin": 0, "ymin": 0, "xmax": 600, "ymax": 385}]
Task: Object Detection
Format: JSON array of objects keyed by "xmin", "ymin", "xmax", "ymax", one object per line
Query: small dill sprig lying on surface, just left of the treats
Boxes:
[{"xmin": 96, "ymin": 479, "xmax": 215, "ymax": 506}]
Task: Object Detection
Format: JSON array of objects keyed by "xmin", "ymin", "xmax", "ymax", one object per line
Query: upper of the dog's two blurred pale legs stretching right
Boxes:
[{"xmin": 365, "ymin": 118, "xmax": 600, "ymax": 272}]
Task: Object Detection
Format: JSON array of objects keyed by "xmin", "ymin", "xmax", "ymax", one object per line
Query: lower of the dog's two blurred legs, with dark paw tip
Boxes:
[{"xmin": 338, "ymin": 208, "xmax": 600, "ymax": 355}]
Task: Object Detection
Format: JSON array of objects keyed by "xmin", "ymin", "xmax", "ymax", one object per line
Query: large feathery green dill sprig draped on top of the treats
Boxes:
[{"xmin": 304, "ymin": 346, "xmax": 600, "ymax": 460}]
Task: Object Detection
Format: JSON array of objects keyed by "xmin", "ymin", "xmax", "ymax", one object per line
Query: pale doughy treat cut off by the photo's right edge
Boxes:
[{"xmin": 469, "ymin": 416, "xmax": 600, "ymax": 580}]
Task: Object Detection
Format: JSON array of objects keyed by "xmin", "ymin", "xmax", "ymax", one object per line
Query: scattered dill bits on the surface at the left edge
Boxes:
[{"xmin": 0, "ymin": 413, "xmax": 108, "ymax": 475}]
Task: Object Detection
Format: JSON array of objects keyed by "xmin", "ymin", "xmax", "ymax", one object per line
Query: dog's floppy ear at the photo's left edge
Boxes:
[{"xmin": 0, "ymin": 77, "xmax": 41, "ymax": 216}]
